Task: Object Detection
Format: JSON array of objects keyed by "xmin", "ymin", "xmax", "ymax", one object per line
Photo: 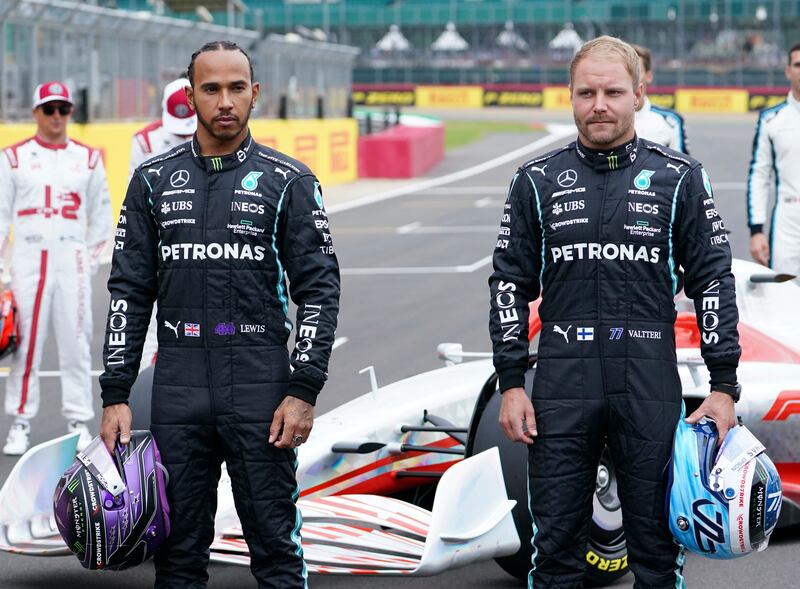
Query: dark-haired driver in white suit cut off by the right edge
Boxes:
[{"xmin": 747, "ymin": 43, "xmax": 800, "ymax": 276}]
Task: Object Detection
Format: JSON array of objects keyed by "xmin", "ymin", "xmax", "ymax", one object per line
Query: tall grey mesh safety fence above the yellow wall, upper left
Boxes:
[{"xmin": 0, "ymin": 0, "xmax": 358, "ymax": 121}]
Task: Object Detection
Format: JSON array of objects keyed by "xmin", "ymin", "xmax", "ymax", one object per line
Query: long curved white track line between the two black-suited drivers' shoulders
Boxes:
[{"xmin": 327, "ymin": 125, "xmax": 575, "ymax": 214}]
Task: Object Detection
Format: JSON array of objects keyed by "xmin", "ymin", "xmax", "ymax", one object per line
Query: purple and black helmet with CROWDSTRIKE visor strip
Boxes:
[{"xmin": 53, "ymin": 430, "xmax": 169, "ymax": 570}]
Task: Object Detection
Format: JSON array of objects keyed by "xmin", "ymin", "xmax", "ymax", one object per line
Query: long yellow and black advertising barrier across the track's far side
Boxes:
[{"xmin": 352, "ymin": 84, "xmax": 788, "ymax": 113}]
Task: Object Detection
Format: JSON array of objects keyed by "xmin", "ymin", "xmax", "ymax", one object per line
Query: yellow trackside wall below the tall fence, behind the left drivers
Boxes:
[{"xmin": 0, "ymin": 119, "xmax": 358, "ymax": 221}]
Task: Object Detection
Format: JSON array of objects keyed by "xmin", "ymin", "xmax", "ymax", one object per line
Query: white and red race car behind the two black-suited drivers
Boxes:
[{"xmin": 0, "ymin": 260, "xmax": 800, "ymax": 585}]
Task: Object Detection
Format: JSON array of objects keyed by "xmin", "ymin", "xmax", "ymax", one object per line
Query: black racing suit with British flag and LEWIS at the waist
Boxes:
[{"xmin": 100, "ymin": 136, "xmax": 339, "ymax": 589}]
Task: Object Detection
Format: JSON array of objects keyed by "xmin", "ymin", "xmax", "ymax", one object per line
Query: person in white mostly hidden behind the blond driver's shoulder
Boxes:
[{"xmin": 632, "ymin": 45, "xmax": 689, "ymax": 155}]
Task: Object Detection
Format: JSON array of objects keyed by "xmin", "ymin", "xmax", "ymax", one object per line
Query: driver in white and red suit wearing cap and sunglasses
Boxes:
[{"xmin": 0, "ymin": 82, "xmax": 112, "ymax": 456}]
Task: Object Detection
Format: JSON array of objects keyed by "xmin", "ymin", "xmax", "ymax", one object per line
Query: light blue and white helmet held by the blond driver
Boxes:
[{"xmin": 667, "ymin": 415, "xmax": 783, "ymax": 559}]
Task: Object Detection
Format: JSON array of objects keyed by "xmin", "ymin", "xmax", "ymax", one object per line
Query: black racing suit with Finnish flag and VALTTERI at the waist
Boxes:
[{"xmin": 489, "ymin": 139, "xmax": 740, "ymax": 589}]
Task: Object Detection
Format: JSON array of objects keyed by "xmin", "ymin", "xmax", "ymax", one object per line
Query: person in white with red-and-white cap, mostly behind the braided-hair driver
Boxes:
[{"xmin": 128, "ymin": 78, "xmax": 197, "ymax": 370}]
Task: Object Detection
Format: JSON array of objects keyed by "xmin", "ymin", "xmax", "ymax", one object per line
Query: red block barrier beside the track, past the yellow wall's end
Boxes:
[{"xmin": 358, "ymin": 125, "xmax": 444, "ymax": 178}]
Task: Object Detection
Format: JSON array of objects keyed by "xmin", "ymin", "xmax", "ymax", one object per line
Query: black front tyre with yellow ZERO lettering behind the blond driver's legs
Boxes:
[{"xmin": 467, "ymin": 368, "xmax": 628, "ymax": 587}]
